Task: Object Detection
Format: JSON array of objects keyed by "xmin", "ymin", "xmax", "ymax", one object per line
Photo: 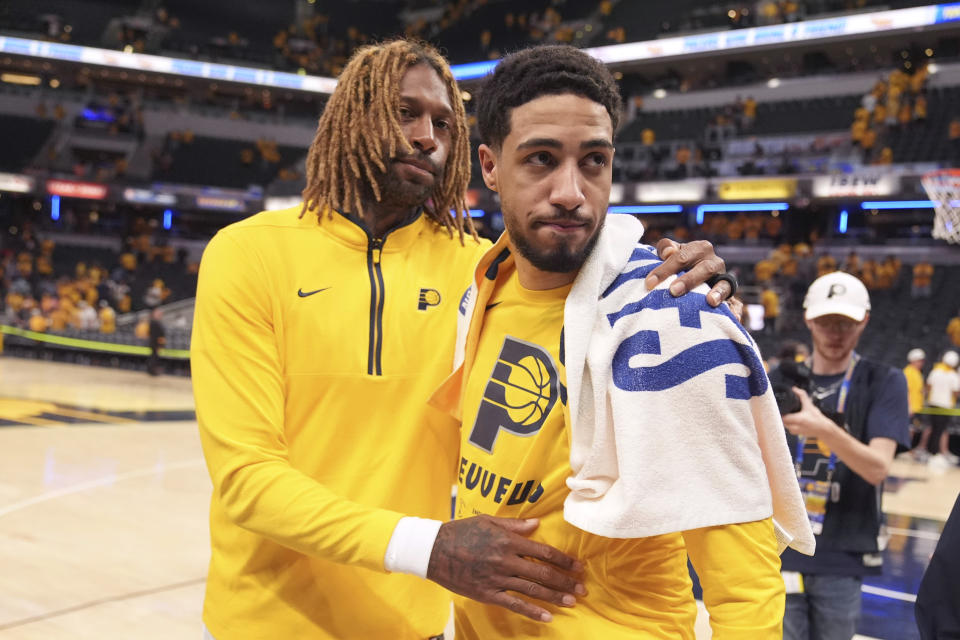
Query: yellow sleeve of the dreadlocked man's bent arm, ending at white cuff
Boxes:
[{"xmin": 190, "ymin": 233, "xmax": 402, "ymax": 571}]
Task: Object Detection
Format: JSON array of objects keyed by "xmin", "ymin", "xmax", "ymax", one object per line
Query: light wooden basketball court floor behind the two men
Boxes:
[{"xmin": 0, "ymin": 357, "xmax": 960, "ymax": 640}]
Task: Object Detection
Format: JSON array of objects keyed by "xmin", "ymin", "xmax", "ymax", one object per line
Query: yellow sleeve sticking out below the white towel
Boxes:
[{"xmin": 683, "ymin": 518, "xmax": 786, "ymax": 640}]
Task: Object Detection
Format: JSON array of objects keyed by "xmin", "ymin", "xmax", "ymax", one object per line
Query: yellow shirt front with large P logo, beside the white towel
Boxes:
[{"xmin": 455, "ymin": 269, "xmax": 696, "ymax": 640}]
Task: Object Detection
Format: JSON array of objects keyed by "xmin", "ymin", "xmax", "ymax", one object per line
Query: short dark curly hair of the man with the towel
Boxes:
[{"xmin": 477, "ymin": 45, "xmax": 623, "ymax": 148}]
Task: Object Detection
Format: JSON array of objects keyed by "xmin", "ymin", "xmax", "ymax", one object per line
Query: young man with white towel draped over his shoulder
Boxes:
[{"xmin": 431, "ymin": 47, "xmax": 813, "ymax": 640}]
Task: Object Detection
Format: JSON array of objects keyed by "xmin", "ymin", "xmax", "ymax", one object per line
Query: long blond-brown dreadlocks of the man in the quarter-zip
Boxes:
[{"xmin": 300, "ymin": 40, "xmax": 476, "ymax": 243}]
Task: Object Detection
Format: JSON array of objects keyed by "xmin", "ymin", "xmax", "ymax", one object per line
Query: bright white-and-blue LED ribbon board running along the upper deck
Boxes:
[{"xmin": 0, "ymin": 2, "xmax": 960, "ymax": 94}]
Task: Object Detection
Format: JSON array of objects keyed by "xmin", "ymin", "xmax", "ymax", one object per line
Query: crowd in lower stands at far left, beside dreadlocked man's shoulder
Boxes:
[{"xmin": 0, "ymin": 220, "xmax": 197, "ymax": 337}]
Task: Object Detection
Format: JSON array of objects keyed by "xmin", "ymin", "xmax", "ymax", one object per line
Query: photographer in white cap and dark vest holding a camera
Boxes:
[{"xmin": 770, "ymin": 272, "xmax": 909, "ymax": 640}]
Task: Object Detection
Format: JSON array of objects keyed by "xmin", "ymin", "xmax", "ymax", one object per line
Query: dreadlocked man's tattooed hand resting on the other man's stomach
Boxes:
[{"xmin": 427, "ymin": 516, "xmax": 586, "ymax": 622}]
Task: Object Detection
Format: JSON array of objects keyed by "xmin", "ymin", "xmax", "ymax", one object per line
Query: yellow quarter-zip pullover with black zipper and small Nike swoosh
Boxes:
[{"xmin": 191, "ymin": 206, "xmax": 489, "ymax": 640}]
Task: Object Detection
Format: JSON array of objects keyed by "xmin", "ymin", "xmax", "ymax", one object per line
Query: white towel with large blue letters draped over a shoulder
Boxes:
[{"xmin": 568, "ymin": 215, "xmax": 814, "ymax": 554}]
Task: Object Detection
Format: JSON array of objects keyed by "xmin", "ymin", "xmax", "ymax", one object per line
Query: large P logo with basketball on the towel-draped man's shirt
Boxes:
[{"xmin": 470, "ymin": 336, "xmax": 558, "ymax": 453}]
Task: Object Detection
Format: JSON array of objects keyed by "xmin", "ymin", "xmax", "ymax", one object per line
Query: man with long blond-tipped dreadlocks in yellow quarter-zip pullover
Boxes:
[{"xmin": 191, "ymin": 40, "xmax": 726, "ymax": 640}]
